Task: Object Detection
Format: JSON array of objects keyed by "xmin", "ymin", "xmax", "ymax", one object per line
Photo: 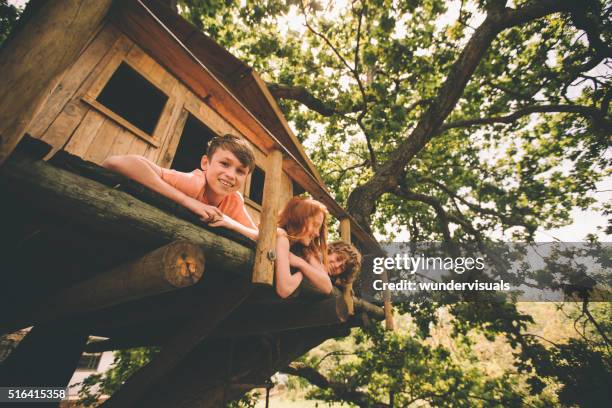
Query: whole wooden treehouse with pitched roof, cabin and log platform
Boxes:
[{"xmin": 0, "ymin": 0, "xmax": 389, "ymax": 407}]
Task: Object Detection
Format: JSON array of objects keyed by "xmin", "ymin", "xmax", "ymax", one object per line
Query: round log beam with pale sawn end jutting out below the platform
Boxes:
[{"xmin": 0, "ymin": 241, "xmax": 204, "ymax": 333}]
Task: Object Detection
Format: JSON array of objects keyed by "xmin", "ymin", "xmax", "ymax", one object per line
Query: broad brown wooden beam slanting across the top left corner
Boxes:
[{"xmin": 0, "ymin": 0, "xmax": 112, "ymax": 165}]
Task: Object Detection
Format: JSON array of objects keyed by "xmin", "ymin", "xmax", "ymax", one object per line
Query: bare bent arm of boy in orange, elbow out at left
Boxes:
[{"xmin": 102, "ymin": 155, "xmax": 223, "ymax": 222}]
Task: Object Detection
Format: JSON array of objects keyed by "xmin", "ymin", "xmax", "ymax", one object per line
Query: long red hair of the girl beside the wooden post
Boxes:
[{"xmin": 278, "ymin": 197, "xmax": 329, "ymax": 269}]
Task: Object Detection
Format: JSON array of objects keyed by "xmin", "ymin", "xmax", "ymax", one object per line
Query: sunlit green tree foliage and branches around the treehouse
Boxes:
[{"xmin": 0, "ymin": 0, "xmax": 612, "ymax": 406}]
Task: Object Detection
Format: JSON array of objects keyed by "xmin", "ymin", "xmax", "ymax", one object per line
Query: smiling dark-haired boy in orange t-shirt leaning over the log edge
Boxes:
[{"xmin": 102, "ymin": 135, "xmax": 257, "ymax": 236}]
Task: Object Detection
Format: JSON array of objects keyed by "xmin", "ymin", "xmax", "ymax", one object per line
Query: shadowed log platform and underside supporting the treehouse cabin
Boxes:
[{"xmin": 0, "ymin": 139, "xmax": 384, "ymax": 407}]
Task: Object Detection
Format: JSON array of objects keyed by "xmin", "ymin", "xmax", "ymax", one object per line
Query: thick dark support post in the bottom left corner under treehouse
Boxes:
[{"xmin": 0, "ymin": 325, "xmax": 88, "ymax": 388}]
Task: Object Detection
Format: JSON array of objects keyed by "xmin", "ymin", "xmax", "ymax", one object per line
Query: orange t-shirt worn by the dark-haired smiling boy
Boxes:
[{"xmin": 161, "ymin": 168, "xmax": 257, "ymax": 229}]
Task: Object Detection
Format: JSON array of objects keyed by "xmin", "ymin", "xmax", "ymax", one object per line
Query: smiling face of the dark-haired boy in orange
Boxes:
[{"xmin": 201, "ymin": 148, "xmax": 249, "ymax": 195}]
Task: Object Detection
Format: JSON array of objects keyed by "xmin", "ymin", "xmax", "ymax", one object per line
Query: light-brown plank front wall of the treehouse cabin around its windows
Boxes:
[{"xmin": 28, "ymin": 23, "xmax": 292, "ymax": 222}]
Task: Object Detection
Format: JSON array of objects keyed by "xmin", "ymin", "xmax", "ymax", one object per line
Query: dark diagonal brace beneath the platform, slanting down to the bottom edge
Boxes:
[{"xmin": 102, "ymin": 281, "xmax": 252, "ymax": 408}]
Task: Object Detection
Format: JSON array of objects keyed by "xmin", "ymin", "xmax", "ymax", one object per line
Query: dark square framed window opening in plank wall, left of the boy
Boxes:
[{"xmin": 96, "ymin": 62, "xmax": 168, "ymax": 135}]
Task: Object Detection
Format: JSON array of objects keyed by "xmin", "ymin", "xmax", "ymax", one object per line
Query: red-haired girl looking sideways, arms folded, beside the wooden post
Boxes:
[{"xmin": 275, "ymin": 197, "xmax": 332, "ymax": 298}]
